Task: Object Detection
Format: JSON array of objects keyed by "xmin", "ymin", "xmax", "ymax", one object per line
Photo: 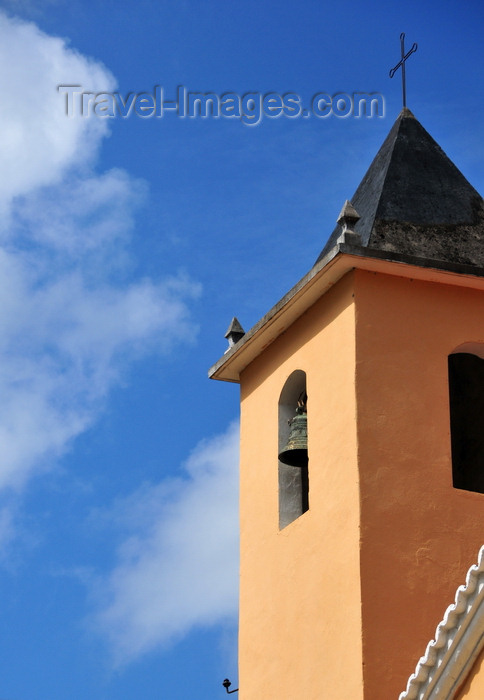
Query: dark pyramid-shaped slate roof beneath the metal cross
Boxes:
[{"xmin": 316, "ymin": 109, "xmax": 484, "ymax": 267}]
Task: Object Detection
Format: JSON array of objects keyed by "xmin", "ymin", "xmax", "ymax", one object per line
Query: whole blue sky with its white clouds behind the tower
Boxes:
[{"xmin": 0, "ymin": 0, "xmax": 484, "ymax": 700}]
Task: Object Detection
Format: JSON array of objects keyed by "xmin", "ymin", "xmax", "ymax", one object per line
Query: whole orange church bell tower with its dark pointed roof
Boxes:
[{"xmin": 210, "ymin": 109, "xmax": 484, "ymax": 700}]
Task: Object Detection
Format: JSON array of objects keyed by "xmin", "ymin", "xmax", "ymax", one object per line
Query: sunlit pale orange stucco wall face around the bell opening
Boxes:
[{"xmin": 239, "ymin": 274, "xmax": 363, "ymax": 700}]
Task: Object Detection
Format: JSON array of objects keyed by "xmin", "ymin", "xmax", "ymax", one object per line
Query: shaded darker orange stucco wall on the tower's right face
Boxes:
[{"xmin": 355, "ymin": 271, "xmax": 484, "ymax": 700}]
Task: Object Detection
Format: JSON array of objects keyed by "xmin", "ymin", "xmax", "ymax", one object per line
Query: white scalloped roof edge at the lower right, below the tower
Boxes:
[{"xmin": 398, "ymin": 546, "xmax": 484, "ymax": 700}]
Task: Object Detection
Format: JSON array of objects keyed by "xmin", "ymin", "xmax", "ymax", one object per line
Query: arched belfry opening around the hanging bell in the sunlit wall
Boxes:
[{"xmin": 278, "ymin": 369, "xmax": 309, "ymax": 530}]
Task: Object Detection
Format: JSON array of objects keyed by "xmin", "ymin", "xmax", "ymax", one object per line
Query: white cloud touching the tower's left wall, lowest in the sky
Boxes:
[{"xmin": 91, "ymin": 424, "xmax": 239, "ymax": 664}]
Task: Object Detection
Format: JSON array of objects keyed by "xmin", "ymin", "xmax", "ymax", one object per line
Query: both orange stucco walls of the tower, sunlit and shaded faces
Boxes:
[{"xmin": 235, "ymin": 265, "xmax": 484, "ymax": 700}]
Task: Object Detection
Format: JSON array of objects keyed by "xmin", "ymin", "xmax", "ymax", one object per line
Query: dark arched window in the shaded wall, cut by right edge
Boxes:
[{"xmin": 449, "ymin": 346, "xmax": 484, "ymax": 493}]
